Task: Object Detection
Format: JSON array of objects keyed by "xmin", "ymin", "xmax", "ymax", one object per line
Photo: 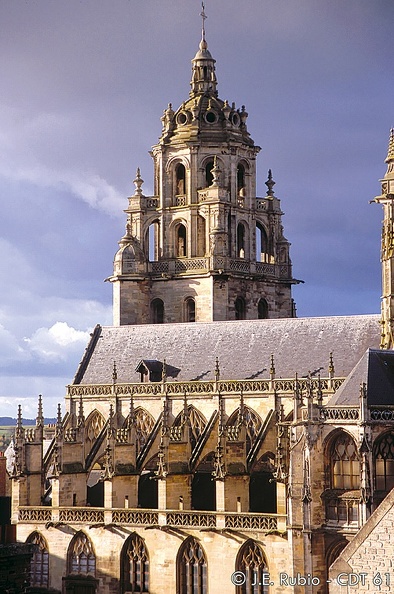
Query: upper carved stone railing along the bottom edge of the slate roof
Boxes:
[{"xmin": 67, "ymin": 378, "xmax": 344, "ymax": 396}]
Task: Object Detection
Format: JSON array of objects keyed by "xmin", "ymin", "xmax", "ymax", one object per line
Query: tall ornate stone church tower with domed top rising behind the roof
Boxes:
[{"xmin": 108, "ymin": 10, "xmax": 297, "ymax": 325}]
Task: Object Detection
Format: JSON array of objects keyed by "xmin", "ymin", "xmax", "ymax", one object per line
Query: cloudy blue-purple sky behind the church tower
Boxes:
[{"xmin": 0, "ymin": 0, "xmax": 394, "ymax": 416}]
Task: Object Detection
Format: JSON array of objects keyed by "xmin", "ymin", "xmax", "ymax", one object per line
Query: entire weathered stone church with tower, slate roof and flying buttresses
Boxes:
[{"xmin": 11, "ymin": 9, "xmax": 394, "ymax": 594}]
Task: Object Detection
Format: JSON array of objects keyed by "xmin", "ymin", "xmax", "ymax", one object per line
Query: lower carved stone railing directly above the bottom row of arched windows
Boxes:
[{"xmin": 18, "ymin": 507, "xmax": 287, "ymax": 533}]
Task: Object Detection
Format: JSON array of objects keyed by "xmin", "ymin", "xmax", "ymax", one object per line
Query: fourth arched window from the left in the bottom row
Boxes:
[{"xmin": 177, "ymin": 536, "xmax": 208, "ymax": 594}]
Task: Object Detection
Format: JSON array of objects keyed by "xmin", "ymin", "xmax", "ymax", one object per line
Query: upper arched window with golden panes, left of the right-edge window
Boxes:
[{"xmin": 331, "ymin": 432, "xmax": 360, "ymax": 489}]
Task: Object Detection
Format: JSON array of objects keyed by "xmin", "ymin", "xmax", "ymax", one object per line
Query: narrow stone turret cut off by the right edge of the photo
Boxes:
[{"xmin": 373, "ymin": 128, "xmax": 394, "ymax": 349}]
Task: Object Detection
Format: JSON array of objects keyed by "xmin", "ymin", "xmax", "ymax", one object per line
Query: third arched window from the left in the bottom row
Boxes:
[{"xmin": 120, "ymin": 533, "xmax": 149, "ymax": 594}]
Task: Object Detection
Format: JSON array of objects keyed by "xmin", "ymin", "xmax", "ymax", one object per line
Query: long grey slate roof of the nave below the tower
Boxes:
[{"xmin": 74, "ymin": 315, "xmax": 380, "ymax": 384}]
